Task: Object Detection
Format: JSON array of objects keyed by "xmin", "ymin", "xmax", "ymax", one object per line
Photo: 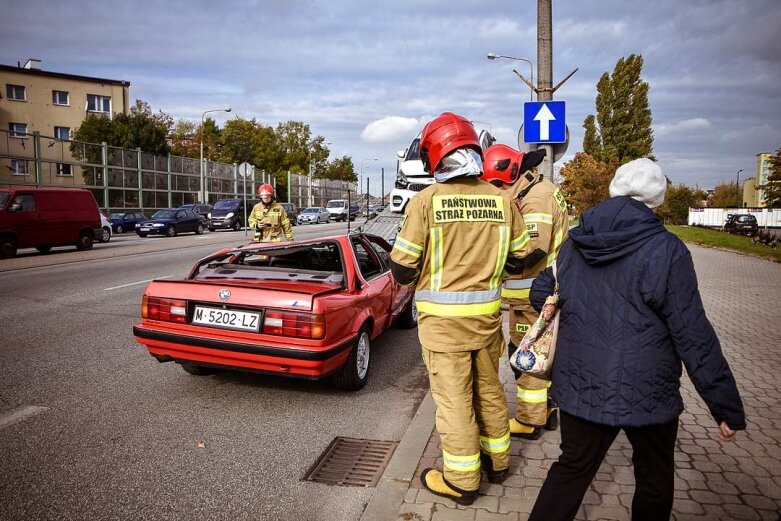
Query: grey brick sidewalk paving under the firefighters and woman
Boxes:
[{"xmin": 362, "ymin": 245, "xmax": 781, "ymax": 521}]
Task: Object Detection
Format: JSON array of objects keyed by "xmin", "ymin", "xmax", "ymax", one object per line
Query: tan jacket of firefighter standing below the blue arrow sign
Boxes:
[{"xmin": 502, "ymin": 172, "xmax": 569, "ymax": 306}]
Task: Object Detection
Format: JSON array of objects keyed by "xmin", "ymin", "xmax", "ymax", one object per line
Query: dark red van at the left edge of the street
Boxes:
[{"xmin": 0, "ymin": 187, "xmax": 101, "ymax": 258}]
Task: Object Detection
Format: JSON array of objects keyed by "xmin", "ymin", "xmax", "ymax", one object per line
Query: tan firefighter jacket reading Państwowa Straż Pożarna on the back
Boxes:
[{"xmin": 391, "ymin": 177, "xmax": 531, "ymax": 352}]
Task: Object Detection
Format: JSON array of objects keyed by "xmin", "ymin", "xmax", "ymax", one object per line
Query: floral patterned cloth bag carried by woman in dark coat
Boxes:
[{"xmin": 510, "ymin": 262, "xmax": 560, "ymax": 378}]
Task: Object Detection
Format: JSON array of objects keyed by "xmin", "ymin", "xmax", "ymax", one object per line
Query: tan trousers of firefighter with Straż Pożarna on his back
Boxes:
[{"xmin": 423, "ymin": 338, "xmax": 510, "ymax": 491}]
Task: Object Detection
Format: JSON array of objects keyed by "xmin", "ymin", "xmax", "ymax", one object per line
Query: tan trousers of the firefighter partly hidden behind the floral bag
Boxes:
[{"xmin": 509, "ymin": 299, "xmax": 551, "ymax": 427}]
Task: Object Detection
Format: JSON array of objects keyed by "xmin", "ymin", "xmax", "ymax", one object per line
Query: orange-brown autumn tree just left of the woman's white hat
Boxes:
[{"xmin": 561, "ymin": 152, "xmax": 618, "ymax": 214}]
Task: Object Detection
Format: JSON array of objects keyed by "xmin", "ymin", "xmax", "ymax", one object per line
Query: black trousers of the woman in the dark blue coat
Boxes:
[{"xmin": 529, "ymin": 411, "xmax": 678, "ymax": 521}]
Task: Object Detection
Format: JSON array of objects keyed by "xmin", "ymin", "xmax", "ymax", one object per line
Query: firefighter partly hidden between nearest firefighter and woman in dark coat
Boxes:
[{"xmin": 483, "ymin": 144, "xmax": 569, "ymax": 440}]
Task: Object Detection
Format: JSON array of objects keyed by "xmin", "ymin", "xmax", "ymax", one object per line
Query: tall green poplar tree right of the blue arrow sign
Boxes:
[{"xmin": 583, "ymin": 54, "xmax": 654, "ymax": 165}]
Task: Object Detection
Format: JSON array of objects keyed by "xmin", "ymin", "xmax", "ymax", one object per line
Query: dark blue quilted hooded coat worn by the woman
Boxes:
[{"xmin": 530, "ymin": 197, "xmax": 746, "ymax": 429}]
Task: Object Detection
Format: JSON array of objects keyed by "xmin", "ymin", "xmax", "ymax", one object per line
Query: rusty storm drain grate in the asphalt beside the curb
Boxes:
[{"xmin": 304, "ymin": 437, "xmax": 398, "ymax": 487}]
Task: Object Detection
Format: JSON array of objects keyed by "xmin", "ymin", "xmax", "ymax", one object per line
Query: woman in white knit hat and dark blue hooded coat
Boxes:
[{"xmin": 529, "ymin": 159, "xmax": 746, "ymax": 521}]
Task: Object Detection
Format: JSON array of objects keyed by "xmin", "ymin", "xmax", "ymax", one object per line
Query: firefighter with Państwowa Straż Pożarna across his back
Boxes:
[{"xmin": 391, "ymin": 112, "xmax": 531, "ymax": 505}]
